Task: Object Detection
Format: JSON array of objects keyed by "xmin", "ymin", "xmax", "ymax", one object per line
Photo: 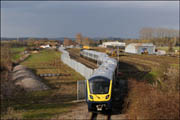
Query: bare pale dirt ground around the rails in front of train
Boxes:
[{"xmin": 53, "ymin": 103, "xmax": 127, "ymax": 120}]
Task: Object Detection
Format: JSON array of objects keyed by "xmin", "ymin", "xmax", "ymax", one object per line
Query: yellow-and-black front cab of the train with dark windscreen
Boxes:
[{"xmin": 86, "ymin": 76, "xmax": 112, "ymax": 112}]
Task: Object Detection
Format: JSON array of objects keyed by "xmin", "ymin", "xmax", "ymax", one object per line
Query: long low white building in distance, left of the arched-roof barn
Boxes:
[{"xmin": 101, "ymin": 41, "xmax": 126, "ymax": 48}]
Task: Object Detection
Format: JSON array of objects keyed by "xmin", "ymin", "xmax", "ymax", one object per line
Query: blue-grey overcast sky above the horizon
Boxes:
[{"xmin": 1, "ymin": 1, "xmax": 179, "ymax": 38}]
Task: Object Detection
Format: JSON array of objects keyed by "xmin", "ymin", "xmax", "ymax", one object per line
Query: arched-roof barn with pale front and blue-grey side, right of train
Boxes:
[{"xmin": 125, "ymin": 43, "xmax": 155, "ymax": 54}]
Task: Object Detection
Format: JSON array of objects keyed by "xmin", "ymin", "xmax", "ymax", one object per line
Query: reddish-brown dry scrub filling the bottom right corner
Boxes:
[{"xmin": 126, "ymin": 79, "xmax": 180, "ymax": 119}]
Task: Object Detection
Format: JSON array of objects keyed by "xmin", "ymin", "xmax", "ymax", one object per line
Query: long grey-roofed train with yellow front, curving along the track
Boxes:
[{"xmin": 80, "ymin": 50, "xmax": 117, "ymax": 112}]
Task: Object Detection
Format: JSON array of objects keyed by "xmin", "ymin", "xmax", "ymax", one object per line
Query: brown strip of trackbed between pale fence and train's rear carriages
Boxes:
[{"xmin": 68, "ymin": 49, "xmax": 97, "ymax": 69}]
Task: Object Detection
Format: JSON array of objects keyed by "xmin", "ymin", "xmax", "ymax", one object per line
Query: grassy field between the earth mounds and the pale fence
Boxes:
[{"xmin": 1, "ymin": 50, "xmax": 84, "ymax": 119}]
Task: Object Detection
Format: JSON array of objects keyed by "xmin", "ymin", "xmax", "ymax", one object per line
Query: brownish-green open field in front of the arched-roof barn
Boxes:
[{"xmin": 119, "ymin": 55, "xmax": 179, "ymax": 81}]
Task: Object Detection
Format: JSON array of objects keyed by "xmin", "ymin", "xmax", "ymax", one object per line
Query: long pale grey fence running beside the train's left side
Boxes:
[{"xmin": 59, "ymin": 47, "xmax": 94, "ymax": 100}]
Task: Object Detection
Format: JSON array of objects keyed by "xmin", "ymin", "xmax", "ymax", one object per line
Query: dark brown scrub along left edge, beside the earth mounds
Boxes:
[{"xmin": 0, "ymin": 45, "xmax": 24, "ymax": 113}]
